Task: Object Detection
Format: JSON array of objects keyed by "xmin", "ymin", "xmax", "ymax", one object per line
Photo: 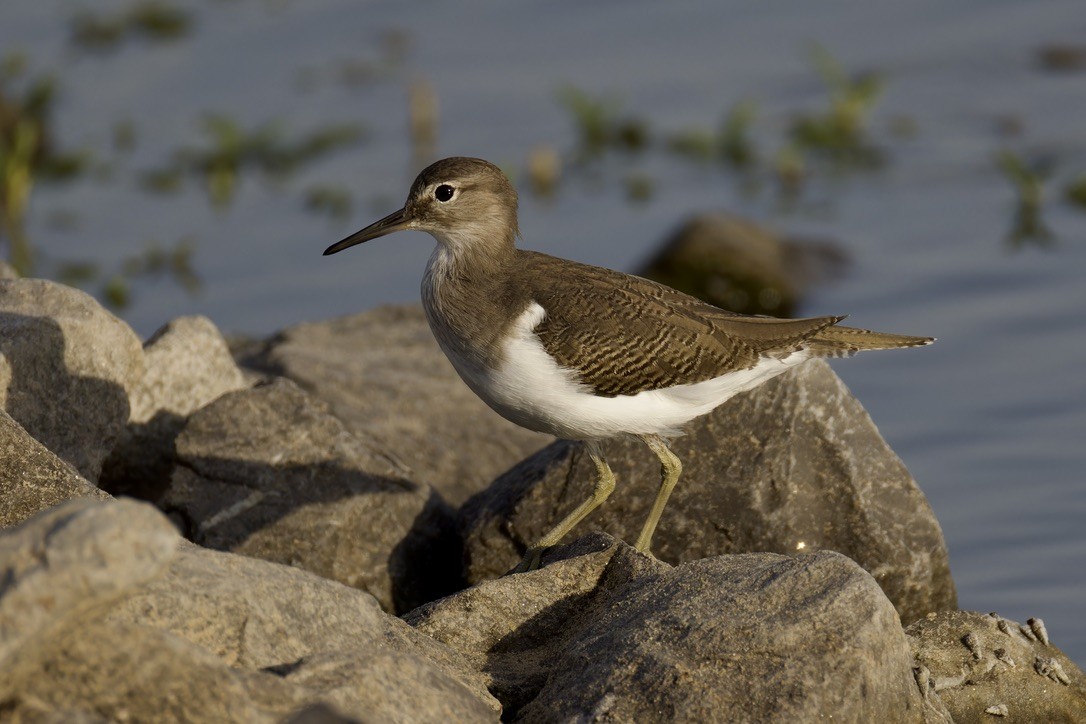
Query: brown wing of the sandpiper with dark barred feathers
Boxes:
[{"xmin": 518, "ymin": 252, "xmax": 842, "ymax": 397}]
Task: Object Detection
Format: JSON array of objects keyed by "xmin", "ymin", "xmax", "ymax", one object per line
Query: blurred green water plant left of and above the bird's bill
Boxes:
[{"xmin": 142, "ymin": 114, "xmax": 365, "ymax": 208}]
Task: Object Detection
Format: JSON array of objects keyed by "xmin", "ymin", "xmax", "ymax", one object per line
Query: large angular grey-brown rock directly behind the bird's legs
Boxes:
[{"xmin": 458, "ymin": 360, "xmax": 956, "ymax": 621}]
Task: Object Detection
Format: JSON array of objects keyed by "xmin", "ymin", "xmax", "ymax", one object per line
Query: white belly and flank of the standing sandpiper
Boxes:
[{"xmin": 432, "ymin": 304, "xmax": 808, "ymax": 440}]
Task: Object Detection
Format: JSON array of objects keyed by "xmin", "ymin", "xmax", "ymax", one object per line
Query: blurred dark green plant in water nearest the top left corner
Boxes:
[{"xmin": 68, "ymin": 0, "xmax": 193, "ymax": 52}]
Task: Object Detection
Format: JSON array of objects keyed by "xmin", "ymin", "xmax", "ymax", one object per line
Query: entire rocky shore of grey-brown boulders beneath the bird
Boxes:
[{"xmin": 0, "ymin": 274, "xmax": 1086, "ymax": 723}]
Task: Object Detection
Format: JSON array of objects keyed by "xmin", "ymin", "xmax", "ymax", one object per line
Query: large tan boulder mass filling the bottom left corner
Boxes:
[{"xmin": 0, "ymin": 500, "xmax": 500, "ymax": 723}]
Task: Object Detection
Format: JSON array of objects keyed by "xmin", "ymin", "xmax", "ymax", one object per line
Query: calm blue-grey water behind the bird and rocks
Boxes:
[{"xmin": 0, "ymin": 0, "xmax": 1086, "ymax": 664}]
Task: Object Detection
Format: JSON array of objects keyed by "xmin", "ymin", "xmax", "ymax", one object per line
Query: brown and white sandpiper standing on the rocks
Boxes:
[{"xmin": 325, "ymin": 156, "xmax": 934, "ymax": 573}]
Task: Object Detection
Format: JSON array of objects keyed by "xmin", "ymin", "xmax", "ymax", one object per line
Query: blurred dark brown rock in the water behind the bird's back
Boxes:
[{"xmin": 639, "ymin": 213, "xmax": 848, "ymax": 317}]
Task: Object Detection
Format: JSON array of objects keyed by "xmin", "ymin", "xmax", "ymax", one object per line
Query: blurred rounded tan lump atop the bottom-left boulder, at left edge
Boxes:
[{"xmin": 0, "ymin": 499, "xmax": 180, "ymax": 677}]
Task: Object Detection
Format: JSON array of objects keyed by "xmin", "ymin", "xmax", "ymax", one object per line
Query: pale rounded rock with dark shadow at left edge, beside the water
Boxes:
[{"xmin": 0, "ymin": 279, "xmax": 143, "ymax": 481}]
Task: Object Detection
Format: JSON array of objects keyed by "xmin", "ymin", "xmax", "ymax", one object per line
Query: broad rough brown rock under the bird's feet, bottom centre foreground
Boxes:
[{"xmin": 407, "ymin": 536, "xmax": 938, "ymax": 722}]
